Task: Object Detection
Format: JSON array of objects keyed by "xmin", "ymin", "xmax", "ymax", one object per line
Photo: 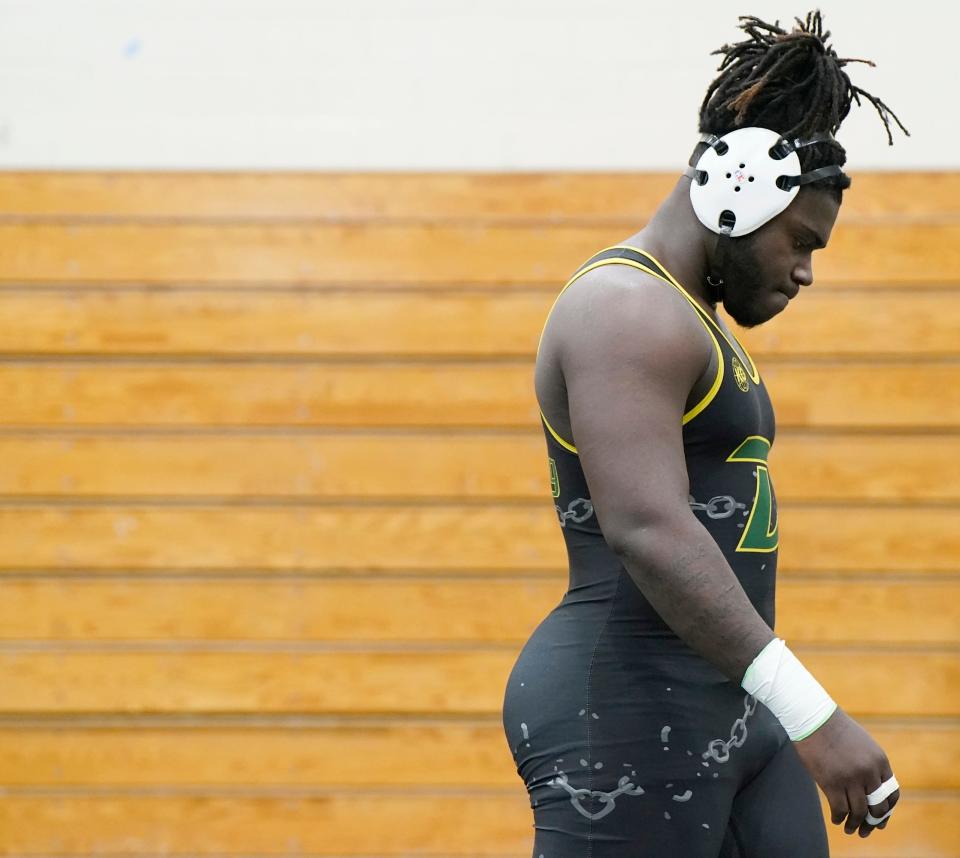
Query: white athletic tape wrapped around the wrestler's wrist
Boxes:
[{"xmin": 740, "ymin": 638, "xmax": 837, "ymax": 742}]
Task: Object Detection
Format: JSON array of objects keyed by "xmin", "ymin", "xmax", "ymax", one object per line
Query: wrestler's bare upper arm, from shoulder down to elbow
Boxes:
[{"xmin": 564, "ymin": 284, "xmax": 709, "ymax": 546}]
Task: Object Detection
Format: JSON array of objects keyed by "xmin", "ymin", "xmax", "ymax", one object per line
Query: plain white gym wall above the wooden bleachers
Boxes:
[{"xmin": 0, "ymin": 0, "xmax": 944, "ymax": 171}]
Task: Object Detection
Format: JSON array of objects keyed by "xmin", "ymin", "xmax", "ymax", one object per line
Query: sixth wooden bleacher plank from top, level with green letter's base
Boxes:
[{"xmin": 0, "ymin": 502, "xmax": 960, "ymax": 575}]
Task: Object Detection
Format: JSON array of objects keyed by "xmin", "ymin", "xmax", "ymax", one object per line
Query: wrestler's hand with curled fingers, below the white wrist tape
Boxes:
[{"xmin": 793, "ymin": 706, "xmax": 900, "ymax": 837}]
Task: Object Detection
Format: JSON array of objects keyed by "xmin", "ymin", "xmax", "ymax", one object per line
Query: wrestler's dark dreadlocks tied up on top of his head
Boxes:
[{"xmin": 697, "ymin": 9, "xmax": 910, "ymax": 203}]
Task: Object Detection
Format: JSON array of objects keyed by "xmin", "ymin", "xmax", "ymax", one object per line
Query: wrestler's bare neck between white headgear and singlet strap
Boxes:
[{"xmin": 629, "ymin": 176, "xmax": 717, "ymax": 310}]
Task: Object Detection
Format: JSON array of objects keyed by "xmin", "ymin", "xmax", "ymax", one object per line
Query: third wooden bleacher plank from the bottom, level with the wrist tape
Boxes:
[{"xmin": 0, "ymin": 644, "xmax": 960, "ymax": 717}]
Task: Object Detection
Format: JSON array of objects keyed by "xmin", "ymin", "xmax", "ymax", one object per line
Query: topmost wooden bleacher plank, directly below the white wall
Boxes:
[{"xmin": 0, "ymin": 171, "xmax": 960, "ymax": 226}]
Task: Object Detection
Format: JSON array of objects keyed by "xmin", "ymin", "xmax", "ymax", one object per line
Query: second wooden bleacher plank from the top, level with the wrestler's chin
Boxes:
[{"xmin": 0, "ymin": 221, "xmax": 960, "ymax": 285}]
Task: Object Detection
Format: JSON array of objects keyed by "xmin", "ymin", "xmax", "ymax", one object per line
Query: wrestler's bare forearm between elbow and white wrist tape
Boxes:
[{"xmin": 616, "ymin": 516, "xmax": 774, "ymax": 685}]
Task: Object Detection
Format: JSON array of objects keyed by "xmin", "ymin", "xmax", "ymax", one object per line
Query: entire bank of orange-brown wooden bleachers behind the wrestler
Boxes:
[{"xmin": 0, "ymin": 173, "xmax": 960, "ymax": 858}]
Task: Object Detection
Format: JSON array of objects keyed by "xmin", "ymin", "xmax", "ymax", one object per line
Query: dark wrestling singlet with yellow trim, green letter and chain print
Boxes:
[{"xmin": 503, "ymin": 246, "xmax": 828, "ymax": 858}]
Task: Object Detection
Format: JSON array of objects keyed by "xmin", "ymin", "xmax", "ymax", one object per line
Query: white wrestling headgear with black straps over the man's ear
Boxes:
[{"xmin": 684, "ymin": 126, "xmax": 843, "ymax": 238}]
